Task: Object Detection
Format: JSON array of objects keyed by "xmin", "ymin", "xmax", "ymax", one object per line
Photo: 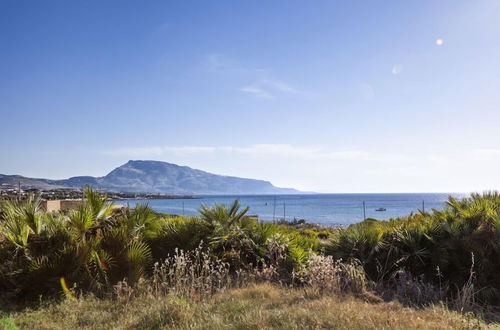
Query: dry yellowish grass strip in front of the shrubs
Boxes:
[{"xmin": 0, "ymin": 284, "xmax": 490, "ymax": 329}]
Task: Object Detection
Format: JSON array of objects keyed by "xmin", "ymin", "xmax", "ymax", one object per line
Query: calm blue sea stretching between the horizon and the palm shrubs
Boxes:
[{"xmin": 117, "ymin": 193, "xmax": 466, "ymax": 226}]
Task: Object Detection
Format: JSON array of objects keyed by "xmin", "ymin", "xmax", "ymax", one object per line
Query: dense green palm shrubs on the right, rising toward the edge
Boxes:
[{"xmin": 325, "ymin": 192, "xmax": 500, "ymax": 309}]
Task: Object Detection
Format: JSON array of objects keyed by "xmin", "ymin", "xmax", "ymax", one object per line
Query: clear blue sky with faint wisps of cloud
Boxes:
[{"xmin": 0, "ymin": 0, "xmax": 500, "ymax": 192}]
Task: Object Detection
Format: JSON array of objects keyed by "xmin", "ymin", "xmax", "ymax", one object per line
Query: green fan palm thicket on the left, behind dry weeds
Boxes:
[{"xmin": 0, "ymin": 189, "xmax": 325, "ymax": 300}]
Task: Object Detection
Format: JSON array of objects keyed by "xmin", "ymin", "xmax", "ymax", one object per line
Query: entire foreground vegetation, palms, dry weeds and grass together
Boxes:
[{"xmin": 0, "ymin": 188, "xmax": 500, "ymax": 328}]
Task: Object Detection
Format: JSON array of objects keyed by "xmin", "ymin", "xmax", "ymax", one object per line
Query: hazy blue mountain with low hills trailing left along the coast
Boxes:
[{"xmin": 0, "ymin": 160, "xmax": 299, "ymax": 195}]
